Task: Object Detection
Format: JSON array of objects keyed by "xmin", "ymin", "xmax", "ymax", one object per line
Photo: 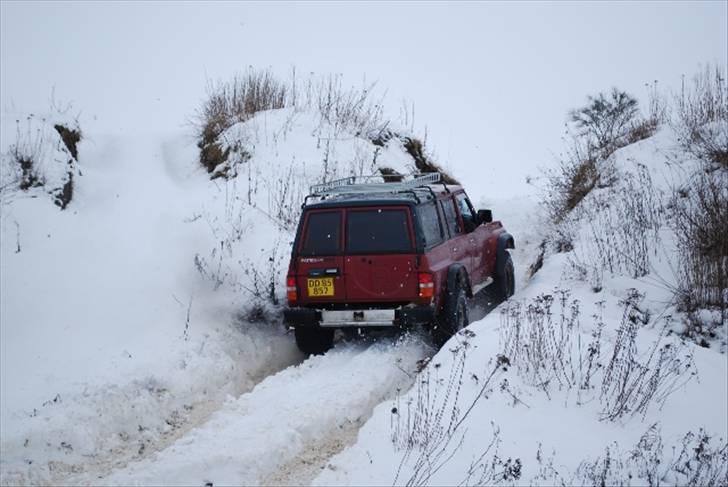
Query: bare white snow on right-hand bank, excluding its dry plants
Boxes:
[{"xmin": 313, "ymin": 129, "xmax": 728, "ymax": 485}]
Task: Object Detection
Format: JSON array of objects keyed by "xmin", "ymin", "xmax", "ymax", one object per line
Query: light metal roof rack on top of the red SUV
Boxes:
[{"xmin": 309, "ymin": 172, "xmax": 442, "ymax": 196}]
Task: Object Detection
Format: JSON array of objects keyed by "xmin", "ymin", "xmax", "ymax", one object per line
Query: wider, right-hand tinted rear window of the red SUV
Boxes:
[{"xmin": 346, "ymin": 209, "xmax": 412, "ymax": 254}]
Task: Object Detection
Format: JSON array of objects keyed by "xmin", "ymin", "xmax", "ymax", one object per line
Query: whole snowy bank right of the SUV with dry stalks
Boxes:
[{"xmin": 314, "ymin": 129, "xmax": 728, "ymax": 485}]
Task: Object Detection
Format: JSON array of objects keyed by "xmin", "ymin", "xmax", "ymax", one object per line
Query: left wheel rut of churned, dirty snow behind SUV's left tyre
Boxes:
[{"xmin": 0, "ymin": 324, "xmax": 305, "ymax": 485}]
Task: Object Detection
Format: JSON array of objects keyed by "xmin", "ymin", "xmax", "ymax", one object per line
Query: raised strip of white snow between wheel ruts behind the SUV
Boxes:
[{"xmin": 93, "ymin": 337, "xmax": 428, "ymax": 485}]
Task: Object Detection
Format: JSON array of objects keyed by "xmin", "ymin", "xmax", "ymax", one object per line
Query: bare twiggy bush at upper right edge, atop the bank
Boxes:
[{"xmin": 673, "ymin": 65, "xmax": 728, "ymax": 169}]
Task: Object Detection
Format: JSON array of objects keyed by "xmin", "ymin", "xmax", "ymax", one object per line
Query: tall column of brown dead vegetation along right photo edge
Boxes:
[{"xmin": 669, "ymin": 66, "xmax": 728, "ymax": 346}]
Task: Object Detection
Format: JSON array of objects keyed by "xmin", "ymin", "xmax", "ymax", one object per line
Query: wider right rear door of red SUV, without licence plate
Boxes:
[{"xmin": 344, "ymin": 206, "xmax": 419, "ymax": 303}]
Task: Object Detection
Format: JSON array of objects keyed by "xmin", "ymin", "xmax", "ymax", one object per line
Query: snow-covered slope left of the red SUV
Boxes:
[{"xmin": 0, "ymin": 110, "xmax": 430, "ymax": 484}]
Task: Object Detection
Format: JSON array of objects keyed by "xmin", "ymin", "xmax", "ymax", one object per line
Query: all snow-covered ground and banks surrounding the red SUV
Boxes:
[{"xmin": 0, "ymin": 73, "xmax": 728, "ymax": 485}]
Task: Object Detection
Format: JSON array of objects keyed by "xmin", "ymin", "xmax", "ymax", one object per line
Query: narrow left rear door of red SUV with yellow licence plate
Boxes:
[{"xmin": 296, "ymin": 209, "xmax": 346, "ymax": 304}]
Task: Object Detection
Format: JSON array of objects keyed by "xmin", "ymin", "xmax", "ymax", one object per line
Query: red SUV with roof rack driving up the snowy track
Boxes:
[{"xmin": 284, "ymin": 173, "xmax": 514, "ymax": 353}]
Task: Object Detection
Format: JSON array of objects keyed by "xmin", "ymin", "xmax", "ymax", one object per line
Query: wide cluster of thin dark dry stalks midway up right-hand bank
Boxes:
[{"xmin": 501, "ymin": 290, "xmax": 696, "ymax": 421}]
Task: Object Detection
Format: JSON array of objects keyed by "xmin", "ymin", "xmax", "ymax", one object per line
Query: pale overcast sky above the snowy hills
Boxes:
[{"xmin": 0, "ymin": 1, "xmax": 728, "ymax": 196}]
